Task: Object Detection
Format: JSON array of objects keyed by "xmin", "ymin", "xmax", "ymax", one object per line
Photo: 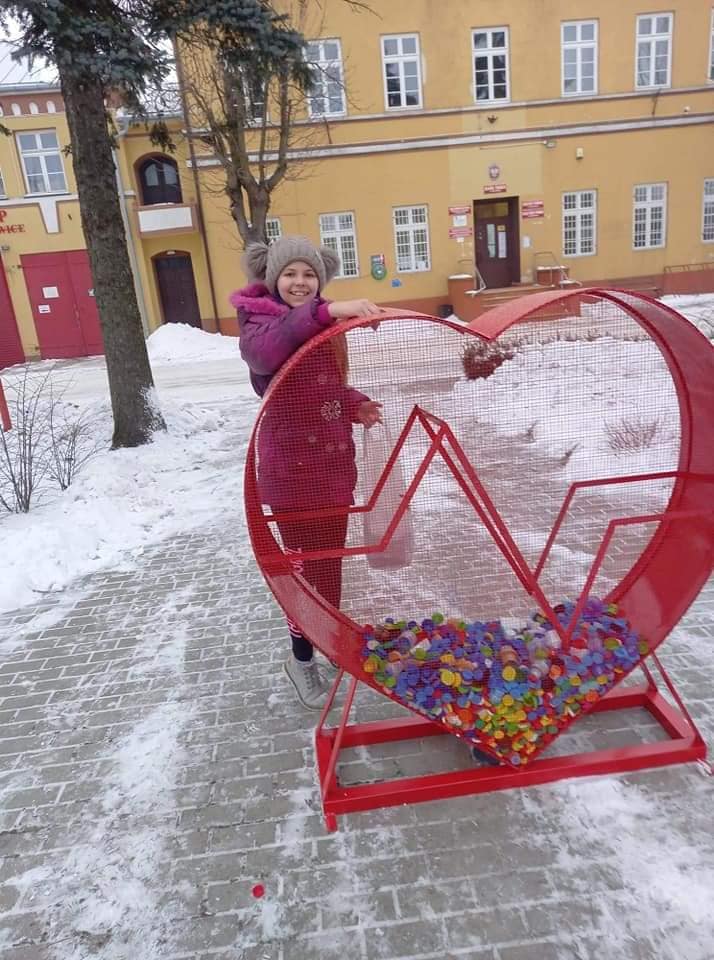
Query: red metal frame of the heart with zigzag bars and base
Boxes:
[{"xmin": 245, "ymin": 288, "xmax": 714, "ymax": 816}]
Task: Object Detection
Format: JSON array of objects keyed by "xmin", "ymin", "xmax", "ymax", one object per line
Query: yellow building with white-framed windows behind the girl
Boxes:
[{"xmin": 0, "ymin": 0, "xmax": 714, "ymax": 356}]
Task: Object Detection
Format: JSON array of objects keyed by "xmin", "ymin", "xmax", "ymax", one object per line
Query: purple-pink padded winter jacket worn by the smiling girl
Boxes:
[{"xmin": 230, "ymin": 283, "xmax": 368, "ymax": 511}]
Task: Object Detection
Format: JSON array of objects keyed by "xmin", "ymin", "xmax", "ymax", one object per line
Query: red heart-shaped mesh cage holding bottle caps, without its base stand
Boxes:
[{"xmin": 245, "ymin": 289, "xmax": 714, "ymax": 763}]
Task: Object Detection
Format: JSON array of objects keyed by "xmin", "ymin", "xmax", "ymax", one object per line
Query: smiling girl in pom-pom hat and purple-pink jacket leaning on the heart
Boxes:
[{"xmin": 230, "ymin": 237, "xmax": 381, "ymax": 710}]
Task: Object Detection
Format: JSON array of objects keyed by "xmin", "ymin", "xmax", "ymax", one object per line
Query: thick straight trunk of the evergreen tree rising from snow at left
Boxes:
[{"xmin": 58, "ymin": 70, "xmax": 166, "ymax": 448}]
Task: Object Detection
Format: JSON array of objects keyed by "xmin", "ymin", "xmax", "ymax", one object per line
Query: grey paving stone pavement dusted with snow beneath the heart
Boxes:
[{"xmin": 0, "ymin": 505, "xmax": 714, "ymax": 960}]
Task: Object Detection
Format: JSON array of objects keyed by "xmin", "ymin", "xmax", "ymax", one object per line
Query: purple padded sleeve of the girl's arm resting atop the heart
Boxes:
[{"xmin": 239, "ymin": 300, "xmax": 333, "ymax": 376}]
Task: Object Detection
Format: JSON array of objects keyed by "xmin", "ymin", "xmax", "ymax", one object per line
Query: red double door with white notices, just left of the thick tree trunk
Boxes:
[{"xmin": 20, "ymin": 250, "xmax": 104, "ymax": 359}]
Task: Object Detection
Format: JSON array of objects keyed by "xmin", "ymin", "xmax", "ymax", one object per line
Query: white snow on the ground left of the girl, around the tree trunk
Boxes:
[{"xmin": 0, "ymin": 327, "xmax": 257, "ymax": 610}]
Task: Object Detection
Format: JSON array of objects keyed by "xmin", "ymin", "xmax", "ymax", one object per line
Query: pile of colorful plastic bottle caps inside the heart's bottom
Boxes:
[{"xmin": 362, "ymin": 597, "xmax": 649, "ymax": 766}]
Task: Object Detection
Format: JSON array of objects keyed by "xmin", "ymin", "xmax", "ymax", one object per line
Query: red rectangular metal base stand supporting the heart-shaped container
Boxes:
[{"xmin": 315, "ymin": 655, "xmax": 712, "ymax": 831}]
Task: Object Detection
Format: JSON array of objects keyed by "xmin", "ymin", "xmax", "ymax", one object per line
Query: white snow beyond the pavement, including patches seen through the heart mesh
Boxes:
[{"xmin": 0, "ymin": 295, "xmax": 714, "ymax": 610}]
